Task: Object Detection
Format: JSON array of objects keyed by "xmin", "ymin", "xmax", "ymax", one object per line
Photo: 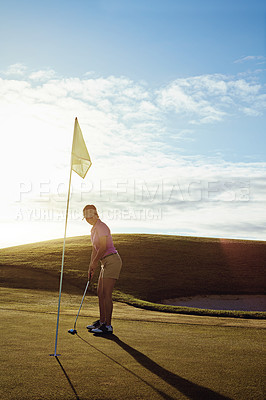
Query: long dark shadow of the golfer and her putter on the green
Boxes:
[{"xmin": 77, "ymin": 334, "xmax": 231, "ymax": 400}]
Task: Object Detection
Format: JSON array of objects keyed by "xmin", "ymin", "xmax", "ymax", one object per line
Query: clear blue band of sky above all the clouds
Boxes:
[{"xmin": 0, "ymin": 0, "xmax": 265, "ymax": 81}]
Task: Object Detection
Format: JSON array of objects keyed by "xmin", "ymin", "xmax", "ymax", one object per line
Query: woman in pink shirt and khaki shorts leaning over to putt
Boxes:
[{"xmin": 83, "ymin": 205, "xmax": 122, "ymax": 334}]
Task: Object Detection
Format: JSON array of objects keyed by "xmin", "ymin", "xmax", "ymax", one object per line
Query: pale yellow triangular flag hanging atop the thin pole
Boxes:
[{"xmin": 71, "ymin": 118, "xmax": 91, "ymax": 178}]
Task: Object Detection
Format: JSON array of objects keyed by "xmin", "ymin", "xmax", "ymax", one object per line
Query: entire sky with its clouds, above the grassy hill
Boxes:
[{"xmin": 0, "ymin": 0, "xmax": 266, "ymax": 246}]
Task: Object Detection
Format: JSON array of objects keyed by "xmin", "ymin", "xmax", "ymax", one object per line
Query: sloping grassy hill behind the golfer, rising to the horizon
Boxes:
[{"xmin": 0, "ymin": 234, "xmax": 266, "ymax": 318}]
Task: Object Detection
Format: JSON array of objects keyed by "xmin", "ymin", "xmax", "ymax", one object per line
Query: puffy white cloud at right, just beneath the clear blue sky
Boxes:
[{"xmin": 157, "ymin": 74, "xmax": 265, "ymax": 124}]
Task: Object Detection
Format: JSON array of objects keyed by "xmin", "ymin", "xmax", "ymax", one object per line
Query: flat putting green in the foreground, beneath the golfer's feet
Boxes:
[{"xmin": 0, "ymin": 289, "xmax": 265, "ymax": 400}]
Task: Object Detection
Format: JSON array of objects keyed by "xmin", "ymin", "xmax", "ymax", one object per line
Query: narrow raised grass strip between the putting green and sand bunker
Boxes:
[{"xmin": 113, "ymin": 290, "xmax": 266, "ymax": 319}]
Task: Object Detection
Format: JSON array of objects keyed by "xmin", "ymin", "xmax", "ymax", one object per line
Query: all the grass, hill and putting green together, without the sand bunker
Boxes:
[{"xmin": 0, "ymin": 235, "xmax": 266, "ymax": 400}]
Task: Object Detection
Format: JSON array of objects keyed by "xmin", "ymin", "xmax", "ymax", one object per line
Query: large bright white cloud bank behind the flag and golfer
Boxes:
[{"xmin": 0, "ymin": 67, "xmax": 266, "ymax": 245}]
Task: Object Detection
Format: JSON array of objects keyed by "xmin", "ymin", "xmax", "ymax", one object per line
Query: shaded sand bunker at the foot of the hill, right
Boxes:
[{"xmin": 162, "ymin": 295, "xmax": 266, "ymax": 311}]
